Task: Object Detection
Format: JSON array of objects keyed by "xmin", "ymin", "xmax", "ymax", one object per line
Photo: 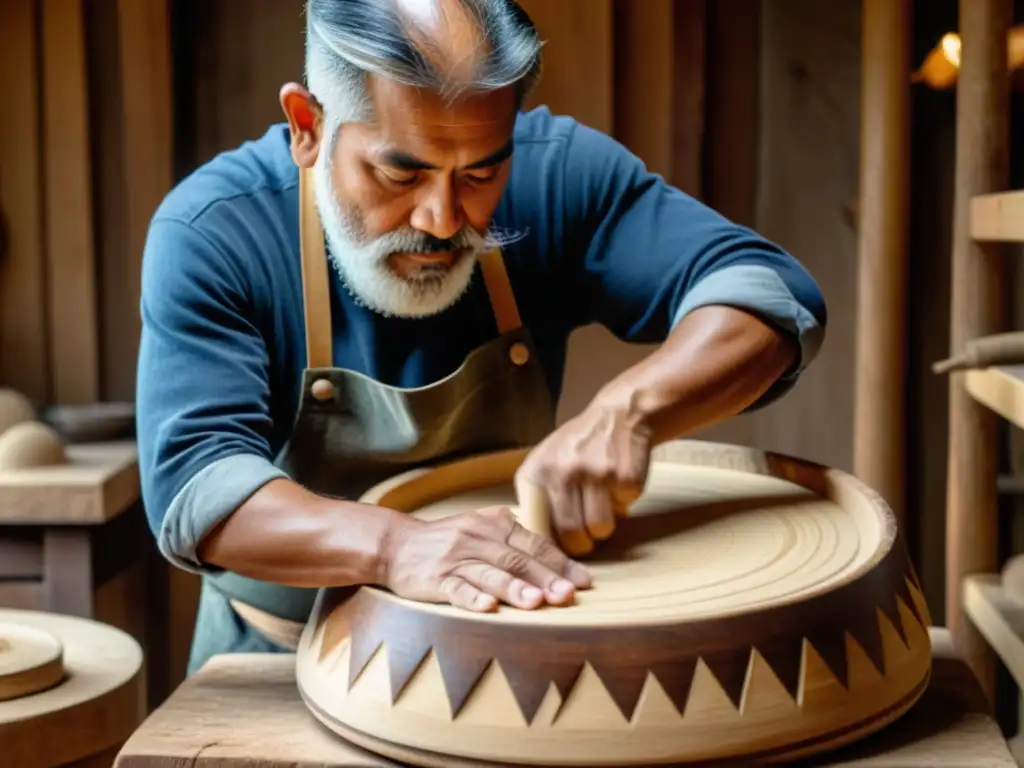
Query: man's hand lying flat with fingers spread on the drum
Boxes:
[{"xmin": 380, "ymin": 507, "xmax": 590, "ymax": 612}]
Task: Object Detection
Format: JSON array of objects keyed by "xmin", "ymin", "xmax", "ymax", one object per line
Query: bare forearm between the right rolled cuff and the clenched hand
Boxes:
[{"xmin": 594, "ymin": 306, "xmax": 800, "ymax": 443}]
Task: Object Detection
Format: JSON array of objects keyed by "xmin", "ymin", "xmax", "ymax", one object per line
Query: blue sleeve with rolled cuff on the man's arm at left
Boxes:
[{"xmin": 136, "ymin": 218, "xmax": 285, "ymax": 572}]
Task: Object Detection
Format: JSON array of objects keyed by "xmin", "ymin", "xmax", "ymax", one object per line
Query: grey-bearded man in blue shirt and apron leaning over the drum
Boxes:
[{"xmin": 137, "ymin": 0, "xmax": 825, "ymax": 670}]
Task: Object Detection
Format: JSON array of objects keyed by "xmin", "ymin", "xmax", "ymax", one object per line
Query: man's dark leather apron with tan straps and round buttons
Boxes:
[{"xmin": 189, "ymin": 170, "xmax": 554, "ymax": 672}]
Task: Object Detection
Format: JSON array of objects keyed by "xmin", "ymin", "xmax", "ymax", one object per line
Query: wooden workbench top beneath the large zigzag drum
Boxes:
[{"xmin": 116, "ymin": 629, "xmax": 1017, "ymax": 768}]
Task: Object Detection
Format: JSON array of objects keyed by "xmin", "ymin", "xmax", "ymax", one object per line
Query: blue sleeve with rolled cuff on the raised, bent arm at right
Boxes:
[{"xmin": 563, "ymin": 120, "xmax": 827, "ymax": 409}]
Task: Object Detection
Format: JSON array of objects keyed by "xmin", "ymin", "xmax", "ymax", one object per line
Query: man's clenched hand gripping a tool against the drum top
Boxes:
[{"xmin": 516, "ymin": 398, "xmax": 651, "ymax": 555}]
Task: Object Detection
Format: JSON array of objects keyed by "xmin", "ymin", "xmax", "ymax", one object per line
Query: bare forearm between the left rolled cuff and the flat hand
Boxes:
[{"xmin": 193, "ymin": 478, "xmax": 400, "ymax": 588}]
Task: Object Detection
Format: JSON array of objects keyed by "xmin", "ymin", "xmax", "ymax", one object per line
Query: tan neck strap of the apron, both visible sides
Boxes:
[{"xmin": 299, "ymin": 168, "xmax": 522, "ymax": 368}]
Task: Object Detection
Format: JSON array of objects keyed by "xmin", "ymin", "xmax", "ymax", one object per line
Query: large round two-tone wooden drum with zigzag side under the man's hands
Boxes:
[{"xmin": 297, "ymin": 441, "xmax": 932, "ymax": 768}]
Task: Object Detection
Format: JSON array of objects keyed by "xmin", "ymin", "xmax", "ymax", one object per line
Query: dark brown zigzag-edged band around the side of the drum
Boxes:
[{"xmin": 322, "ymin": 553, "xmax": 929, "ymax": 723}]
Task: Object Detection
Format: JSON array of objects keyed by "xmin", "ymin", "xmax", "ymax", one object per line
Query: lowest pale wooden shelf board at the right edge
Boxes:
[{"xmin": 964, "ymin": 573, "xmax": 1024, "ymax": 686}]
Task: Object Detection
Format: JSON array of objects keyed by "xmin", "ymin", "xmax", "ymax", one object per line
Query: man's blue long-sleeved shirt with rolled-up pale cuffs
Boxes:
[{"xmin": 136, "ymin": 109, "xmax": 826, "ymax": 571}]
